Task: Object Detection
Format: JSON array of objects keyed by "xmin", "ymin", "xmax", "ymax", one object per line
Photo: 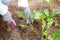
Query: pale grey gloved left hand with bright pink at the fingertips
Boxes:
[{"xmin": 2, "ymin": 11, "xmax": 16, "ymax": 27}]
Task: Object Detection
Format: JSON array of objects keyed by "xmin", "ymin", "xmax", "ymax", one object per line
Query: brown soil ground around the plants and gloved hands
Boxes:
[{"xmin": 0, "ymin": 0, "xmax": 60, "ymax": 40}]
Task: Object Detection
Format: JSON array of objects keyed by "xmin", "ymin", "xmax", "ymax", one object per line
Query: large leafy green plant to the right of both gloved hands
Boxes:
[{"xmin": 31, "ymin": 9, "xmax": 60, "ymax": 40}]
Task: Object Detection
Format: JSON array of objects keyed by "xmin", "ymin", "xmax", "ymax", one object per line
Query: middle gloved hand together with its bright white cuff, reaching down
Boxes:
[{"xmin": 18, "ymin": 0, "xmax": 33, "ymax": 24}]
